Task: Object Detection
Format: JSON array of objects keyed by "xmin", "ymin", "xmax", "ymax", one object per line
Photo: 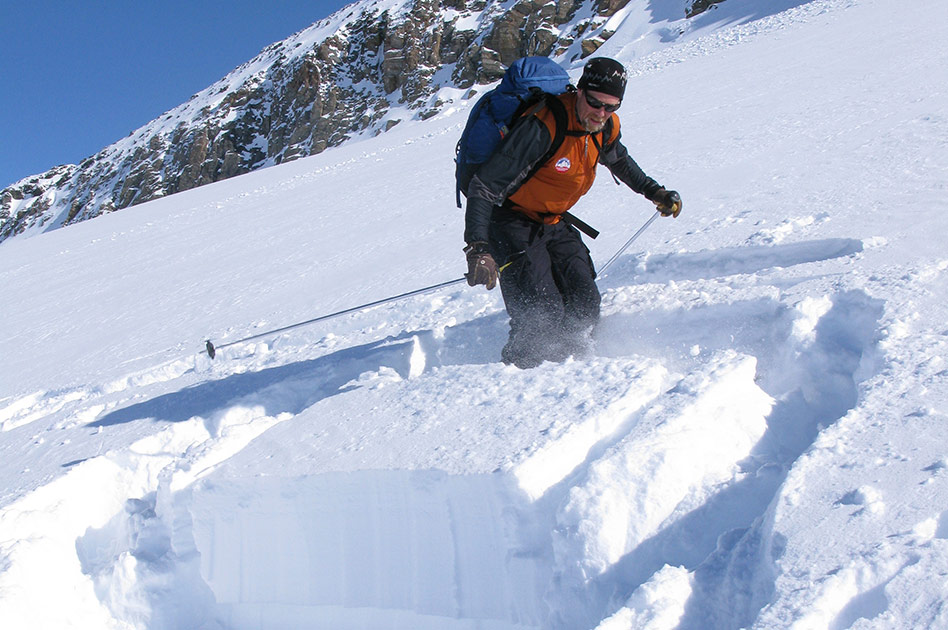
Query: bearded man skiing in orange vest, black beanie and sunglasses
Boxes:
[{"xmin": 464, "ymin": 57, "xmax": 681, "ymax": 368}]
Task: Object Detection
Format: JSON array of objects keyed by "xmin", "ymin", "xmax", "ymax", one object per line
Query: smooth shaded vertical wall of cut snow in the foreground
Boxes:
[{"xmin": 181, "ymin": 470, "xmax": 545, "ymax": 630}]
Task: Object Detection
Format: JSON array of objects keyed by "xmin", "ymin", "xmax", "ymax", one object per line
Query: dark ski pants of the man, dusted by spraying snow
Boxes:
[{"xmin": 489, "ymin": 208, "xmax": 601, "ymax": 368}]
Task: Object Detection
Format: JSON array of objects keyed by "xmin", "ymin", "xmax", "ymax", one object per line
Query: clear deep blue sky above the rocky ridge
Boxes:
[{"xmin": 0, "ymin": 0, "xmax": 354, "ymax": 188}]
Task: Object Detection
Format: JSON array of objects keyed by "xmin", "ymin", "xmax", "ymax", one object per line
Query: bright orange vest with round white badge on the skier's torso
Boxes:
[{"xmin": 508, "ymin": 92, "xmax": 619, "ymax": 223}]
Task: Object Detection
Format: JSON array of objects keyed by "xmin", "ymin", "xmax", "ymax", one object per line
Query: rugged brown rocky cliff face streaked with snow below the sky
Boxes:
[{"xmin": 0, "ymin": 0, "xmax": 704, "ymax": 240}]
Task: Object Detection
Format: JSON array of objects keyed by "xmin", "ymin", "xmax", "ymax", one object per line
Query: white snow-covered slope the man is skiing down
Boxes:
[{"xmin": 0, "ymin": 0, "xmax": 948, "ymax": 630}]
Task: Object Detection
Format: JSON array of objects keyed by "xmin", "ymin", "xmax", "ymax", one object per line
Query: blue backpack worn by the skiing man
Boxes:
[{"xmin": 455, "ymin": 57, "xmax": 572, "ymax": 208}]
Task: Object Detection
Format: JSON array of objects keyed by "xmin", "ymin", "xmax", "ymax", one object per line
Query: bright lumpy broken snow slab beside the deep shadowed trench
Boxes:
[{"xmin": 554, "ymin": 351, "xmax": 773, "ymax": 583}]
